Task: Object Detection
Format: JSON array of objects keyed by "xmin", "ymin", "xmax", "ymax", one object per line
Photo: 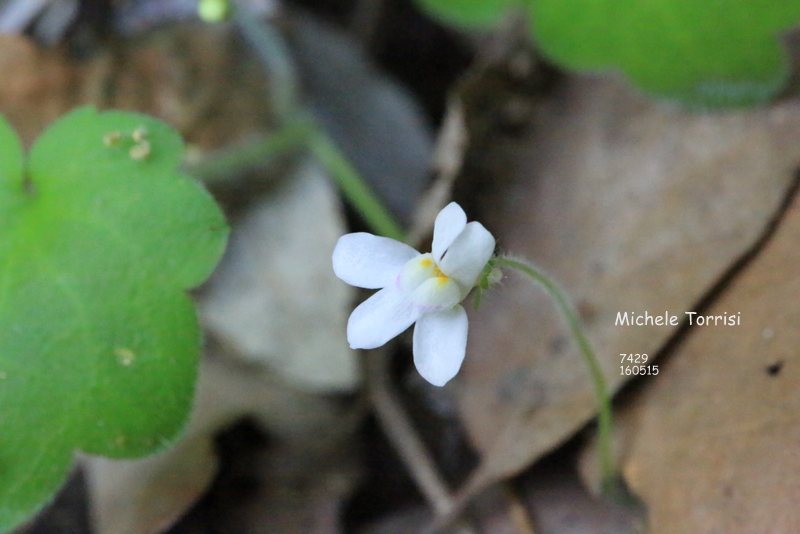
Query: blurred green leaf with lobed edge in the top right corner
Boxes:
[{"xmin": 527, "ymin": 0, "xmax": 800, "ymax": 108}]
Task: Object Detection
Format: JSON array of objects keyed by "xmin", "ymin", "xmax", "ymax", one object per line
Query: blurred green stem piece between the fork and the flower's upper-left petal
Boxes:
[{"xmin": 310, "ymin": 132, "xmax": 405, "ymax": 241}]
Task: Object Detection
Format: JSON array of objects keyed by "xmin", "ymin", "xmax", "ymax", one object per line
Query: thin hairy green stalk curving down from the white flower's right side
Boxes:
[{"xmin": 492, "ymin": 257, "xmax": 616, "ymax": 488}]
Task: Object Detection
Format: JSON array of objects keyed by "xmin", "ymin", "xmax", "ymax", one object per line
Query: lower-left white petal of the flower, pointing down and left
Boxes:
[{"xmin": 347, "ymin": 284, "xmax": 422, "ymax": 349}]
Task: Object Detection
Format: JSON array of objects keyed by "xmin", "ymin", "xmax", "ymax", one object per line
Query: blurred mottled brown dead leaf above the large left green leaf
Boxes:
[{"xmin": 101, "ymin": 23, "xmax": 273, "ymax": 149}]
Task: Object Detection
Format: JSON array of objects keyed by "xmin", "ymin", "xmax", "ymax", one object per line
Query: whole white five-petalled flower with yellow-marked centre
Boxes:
[{"xmin": 333, "ymin": 202, "xmax": 495, "ymax": 386}]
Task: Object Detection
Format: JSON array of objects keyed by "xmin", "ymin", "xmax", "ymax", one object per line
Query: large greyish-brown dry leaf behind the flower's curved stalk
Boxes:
[{"xmin": 456, "ymin": 72, "xmax": 800, "ymax": 496}]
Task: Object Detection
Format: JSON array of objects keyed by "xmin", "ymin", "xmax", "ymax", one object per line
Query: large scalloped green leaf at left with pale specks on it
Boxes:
[{"xmin": 0, "ymin": 108, "xmax": 227, "ymax": 531}]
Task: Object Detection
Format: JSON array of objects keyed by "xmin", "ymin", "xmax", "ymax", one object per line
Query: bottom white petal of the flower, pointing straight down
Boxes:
[{"xmin": 414, "ymin": 306, "xmax": 469, "ymax": 386}]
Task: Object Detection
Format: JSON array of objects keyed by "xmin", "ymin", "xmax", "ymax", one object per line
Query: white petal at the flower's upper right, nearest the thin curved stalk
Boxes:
[{"xmin": 439, "ymin": 221, "xmax": 495, "ymax": 296}]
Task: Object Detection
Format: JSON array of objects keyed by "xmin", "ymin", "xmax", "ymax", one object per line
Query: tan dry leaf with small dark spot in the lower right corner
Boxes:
[{"xmin": 604, "ymin": 188, "xmax": 800, "ymax": 534}]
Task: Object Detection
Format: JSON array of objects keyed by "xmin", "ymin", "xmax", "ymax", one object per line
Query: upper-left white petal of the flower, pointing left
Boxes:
[{"xmin": 333, "ymin": 232, "xmax": 419, "ymax": 289}]
